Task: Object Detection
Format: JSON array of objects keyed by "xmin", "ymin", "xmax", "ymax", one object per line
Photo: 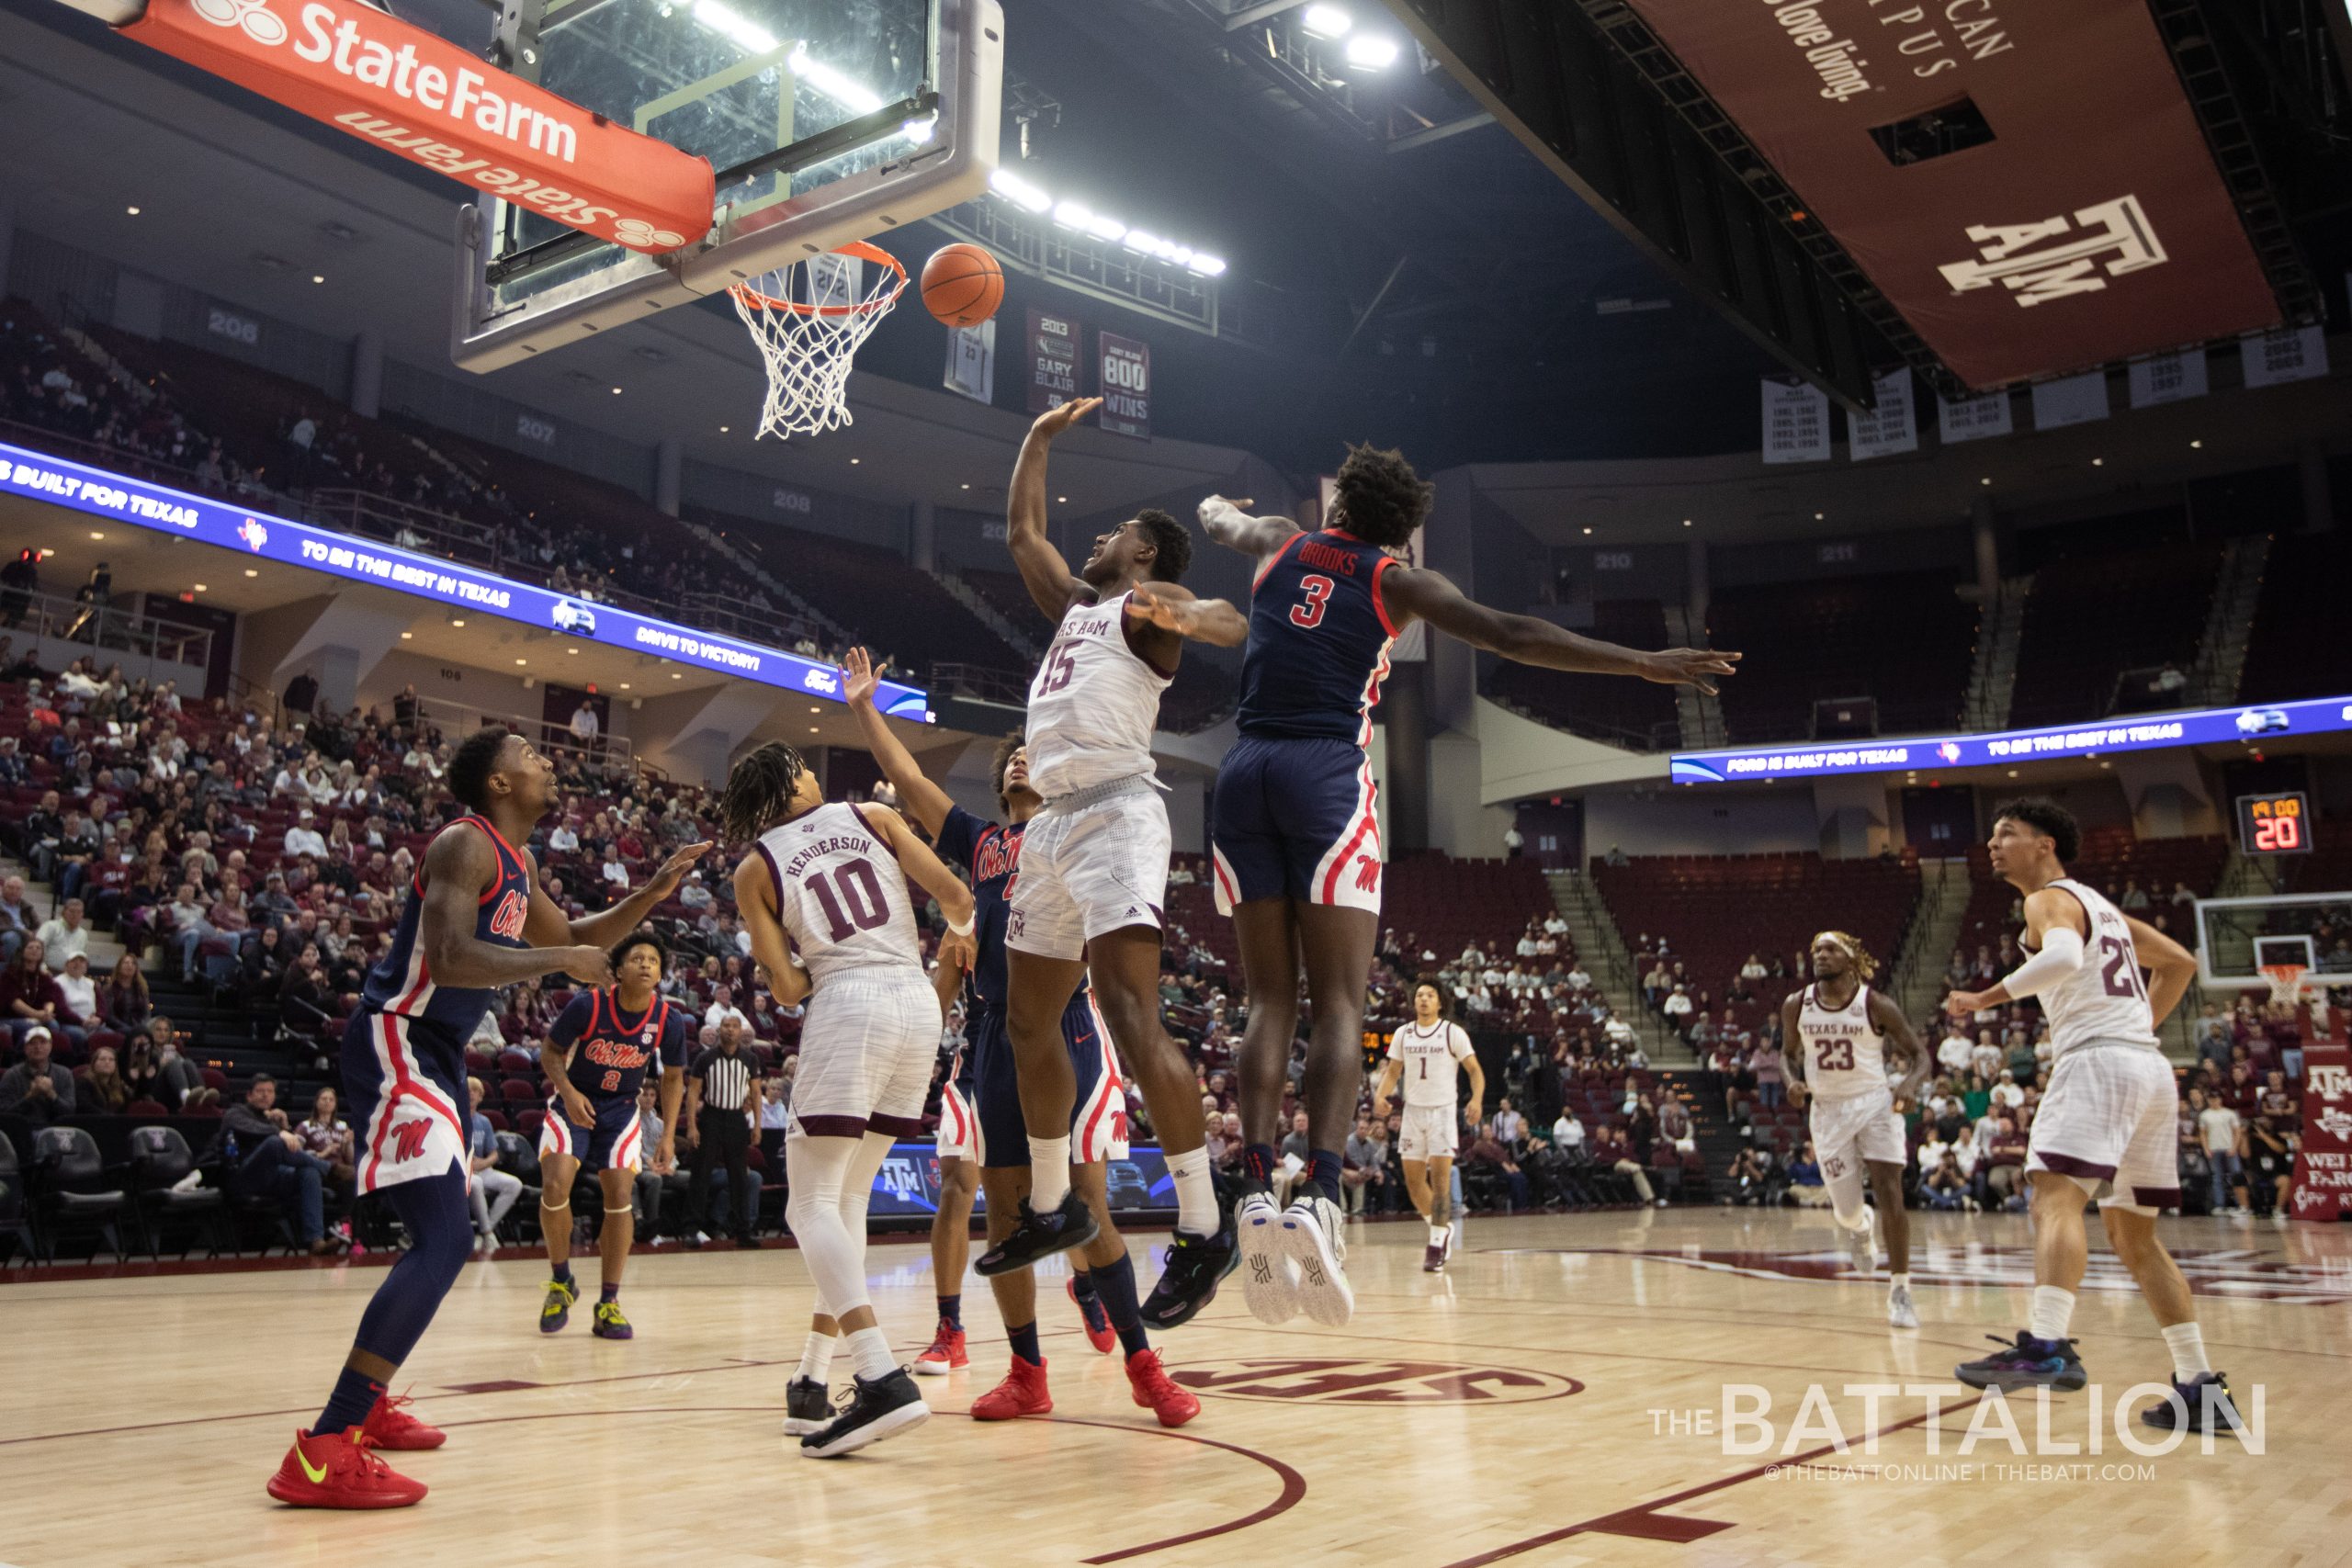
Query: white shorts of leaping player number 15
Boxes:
[{"xmin": 1004, "ymin": 778, "xmax": 1171, "ymax": 959}]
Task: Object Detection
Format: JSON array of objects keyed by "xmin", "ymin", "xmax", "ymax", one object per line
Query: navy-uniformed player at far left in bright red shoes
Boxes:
[{"xmin": 268, "ymin": 727, "xmax": 710, "ymax": 1509}]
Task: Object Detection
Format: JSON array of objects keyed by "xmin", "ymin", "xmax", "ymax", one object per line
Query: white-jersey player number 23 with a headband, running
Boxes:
[{"xmin": 1781, "ymin": 931, "xmax": 1928, "ymax": 1328}]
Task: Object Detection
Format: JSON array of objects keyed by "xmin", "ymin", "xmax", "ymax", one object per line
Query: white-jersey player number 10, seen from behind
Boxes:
[{"xmin": 719, "ymin": 740, "xmax": 971, "ymax": 1460}]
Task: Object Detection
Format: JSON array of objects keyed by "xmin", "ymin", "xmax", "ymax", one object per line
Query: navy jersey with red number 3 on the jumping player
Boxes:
[{"xmin": 1239, "ymin": 529, "xmax": 1397, "ymax": 745}]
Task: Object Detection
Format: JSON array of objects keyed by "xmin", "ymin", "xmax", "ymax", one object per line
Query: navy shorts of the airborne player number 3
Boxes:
[{"xmin": 1209, "ymin": 736, "xmax": 1381, "ymax": 915}]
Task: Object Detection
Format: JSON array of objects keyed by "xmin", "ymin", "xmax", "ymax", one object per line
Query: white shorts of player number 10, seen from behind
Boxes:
[{"xmin": 786, "ymin": 964, "xmax": 938, "ymax": 1138}]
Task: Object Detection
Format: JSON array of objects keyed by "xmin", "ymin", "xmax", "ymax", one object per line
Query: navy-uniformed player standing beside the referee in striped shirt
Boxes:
[{"xmin": 538, "ymin": 931, "xmax": 692, "ymax": 1340}]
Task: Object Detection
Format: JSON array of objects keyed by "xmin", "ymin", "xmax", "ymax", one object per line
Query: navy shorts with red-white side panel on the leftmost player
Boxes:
[{"xmin": 344, "ymin": 1009, "xmax": 473, "ymax": 1192}]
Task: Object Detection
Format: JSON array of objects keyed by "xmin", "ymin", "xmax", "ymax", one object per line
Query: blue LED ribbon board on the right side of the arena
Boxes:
[{"xmin": 1670, "ymin": 696, "xmax": 2352, "ymax": 783}]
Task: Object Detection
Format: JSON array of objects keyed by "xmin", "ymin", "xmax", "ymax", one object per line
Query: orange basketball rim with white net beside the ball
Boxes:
[{"xmin": 727, "ymin": 240, "xmax": 906, "ymax": 440}]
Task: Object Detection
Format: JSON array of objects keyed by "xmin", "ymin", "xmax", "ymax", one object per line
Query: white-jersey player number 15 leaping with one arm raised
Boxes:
[{"xmin": 976, "ymin": 398, "xmax": 1249, "ymax": 1328}]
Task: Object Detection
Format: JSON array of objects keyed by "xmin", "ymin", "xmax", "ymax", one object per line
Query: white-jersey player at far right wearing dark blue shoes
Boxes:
[{"xmin": 1945, "ymin": 799, "xmax": 2242, "ymax": 1432}]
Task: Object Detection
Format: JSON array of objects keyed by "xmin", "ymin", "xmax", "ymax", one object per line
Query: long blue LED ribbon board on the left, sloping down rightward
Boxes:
[{"xmin": 0, "ymin": 442, "xmax": 933, "ymax": 724}]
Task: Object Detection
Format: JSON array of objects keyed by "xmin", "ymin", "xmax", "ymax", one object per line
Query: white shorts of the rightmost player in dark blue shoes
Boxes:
[{"xmin": 2025, "ymin": 1042, "xmax": 2180, "ymax": 1213}]
